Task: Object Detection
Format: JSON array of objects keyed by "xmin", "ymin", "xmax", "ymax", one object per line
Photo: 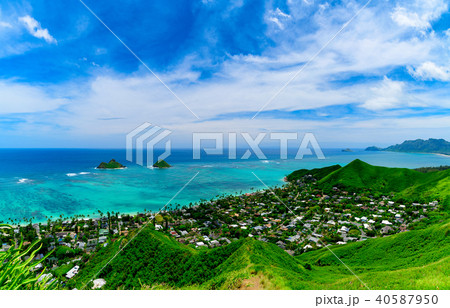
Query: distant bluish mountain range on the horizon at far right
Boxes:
[{"xmin": 366, "ymin": 138, "xmax": 450, "ymax": 155}]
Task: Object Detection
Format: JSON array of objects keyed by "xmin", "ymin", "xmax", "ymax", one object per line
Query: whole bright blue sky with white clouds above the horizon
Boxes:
[{"xmin": 0, "ymin": 0, "xmax": 450, "ymax": 147}]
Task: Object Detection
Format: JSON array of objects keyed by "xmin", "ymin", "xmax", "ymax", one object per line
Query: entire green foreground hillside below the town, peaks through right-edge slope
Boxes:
[{"xmin": 69, "ymin": 223, "xmax": 450, "ymax": 290}]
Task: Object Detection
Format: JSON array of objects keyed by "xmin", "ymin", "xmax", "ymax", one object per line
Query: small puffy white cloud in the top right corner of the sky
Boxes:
[{"xmin": 391, "ymin": 0, "xmax": 448, "ymax": 30}]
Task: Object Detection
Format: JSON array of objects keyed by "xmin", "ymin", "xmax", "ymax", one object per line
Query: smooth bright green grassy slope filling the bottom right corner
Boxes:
[{"xmin": 297, "ymin": 222, "xmax": 450, "ymax": 289}]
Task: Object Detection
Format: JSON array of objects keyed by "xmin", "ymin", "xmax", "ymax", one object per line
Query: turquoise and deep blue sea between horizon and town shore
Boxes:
[{"xmin": 0, "ymin": 149, "xmax": 450, "ymax": 222}]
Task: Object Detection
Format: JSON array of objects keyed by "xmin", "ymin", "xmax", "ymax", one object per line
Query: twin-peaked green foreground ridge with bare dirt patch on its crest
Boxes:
[{"xmin": 69, "ymin": 228, "xmax": 312, "ymax": 289}]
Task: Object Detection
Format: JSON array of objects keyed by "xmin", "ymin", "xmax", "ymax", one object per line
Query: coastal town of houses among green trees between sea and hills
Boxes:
[{"xmin": 0, "ymin": 175, "xmax": 439, "ymax": 288}]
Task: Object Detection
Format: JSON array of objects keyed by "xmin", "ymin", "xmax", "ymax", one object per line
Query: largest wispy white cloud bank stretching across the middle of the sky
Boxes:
[{"xmin": 0, "ymin": 1, "xmax": 450, "ymax": 146}]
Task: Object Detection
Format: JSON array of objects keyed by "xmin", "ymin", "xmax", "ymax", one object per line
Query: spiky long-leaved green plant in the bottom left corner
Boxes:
[{"xmin": 0, "ymin": 224, "xmax": 56, "ymax": 290}]
